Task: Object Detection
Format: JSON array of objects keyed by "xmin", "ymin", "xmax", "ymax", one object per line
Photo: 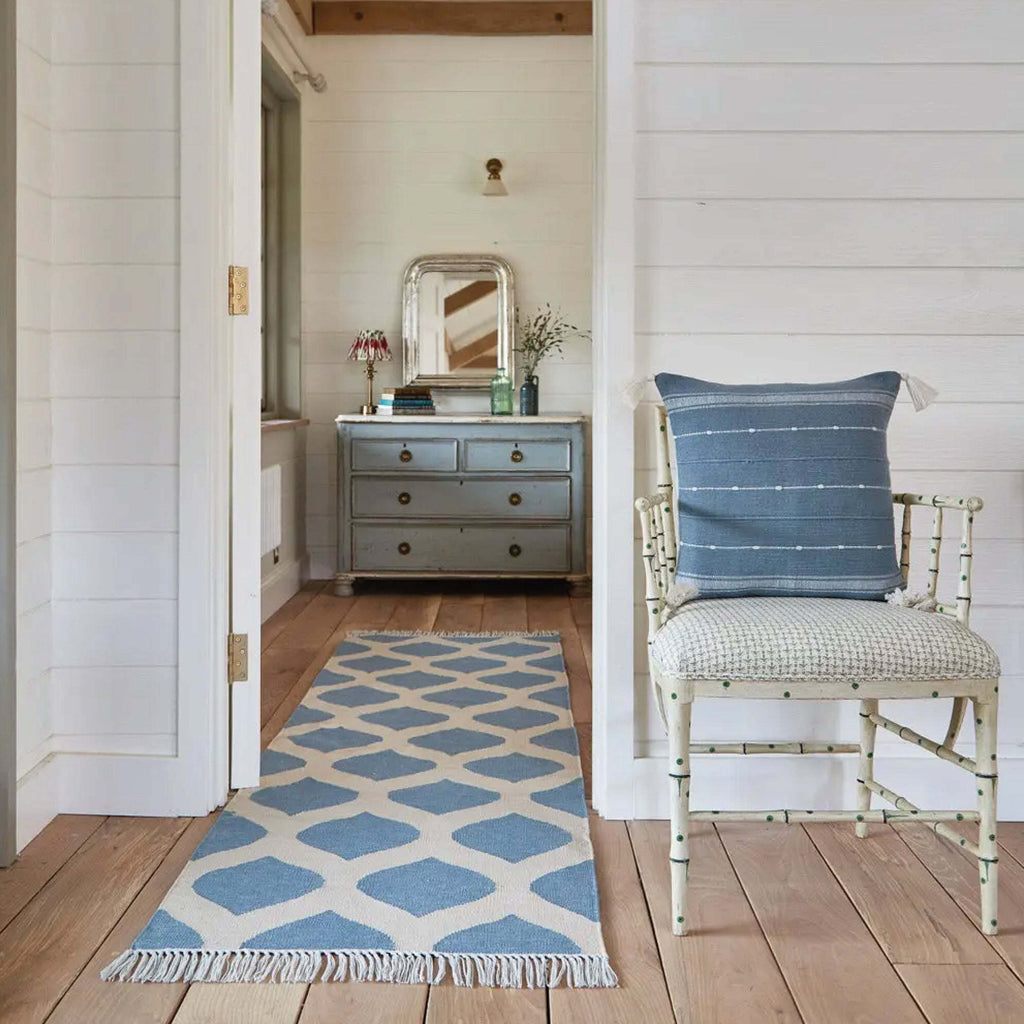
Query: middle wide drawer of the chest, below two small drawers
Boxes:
[{"xmin": 352, "ymin": 475, "xmax": 571, "ymax": 519}]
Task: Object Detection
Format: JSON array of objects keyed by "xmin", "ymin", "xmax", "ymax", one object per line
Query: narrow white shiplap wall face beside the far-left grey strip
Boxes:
[{"xmin": 15, "ymin": 0, "xmax": 56, "ymax": 848}]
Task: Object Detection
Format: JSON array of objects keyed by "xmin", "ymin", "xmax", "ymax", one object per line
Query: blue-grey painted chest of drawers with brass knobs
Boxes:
[{"xmin": 335, "ymin": 415, "xmax": 588, "ymax": 595}]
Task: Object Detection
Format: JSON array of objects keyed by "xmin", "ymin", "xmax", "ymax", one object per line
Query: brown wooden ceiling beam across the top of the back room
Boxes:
[{"xmin": 311, "ymin": 0, "xmax": 593, "ymax": 36}]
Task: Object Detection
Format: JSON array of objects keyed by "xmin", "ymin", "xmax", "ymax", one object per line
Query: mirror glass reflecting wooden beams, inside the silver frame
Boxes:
[{"xmin": 419, "ymin": 271, "xmax": 498, "ymax": 380}]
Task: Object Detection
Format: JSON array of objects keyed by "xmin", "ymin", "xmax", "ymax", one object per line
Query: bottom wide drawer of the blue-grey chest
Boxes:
[{"xmin": 352, "ymin": 522, "xmax": 569, "ymax": 573}]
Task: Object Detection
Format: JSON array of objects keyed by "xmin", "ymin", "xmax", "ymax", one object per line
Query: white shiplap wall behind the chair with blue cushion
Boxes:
[{"xmin": 636, "ymin": 0, "xmax": 1024, "ymax": 817}]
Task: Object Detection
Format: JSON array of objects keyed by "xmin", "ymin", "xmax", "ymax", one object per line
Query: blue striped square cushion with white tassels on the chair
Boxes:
[{"xmin": 655, "ymin": 373, "xmax": 902, "ymax": 600}]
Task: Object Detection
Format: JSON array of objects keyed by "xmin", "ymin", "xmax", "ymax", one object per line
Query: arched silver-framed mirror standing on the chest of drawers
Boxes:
[{"xmin": 401, "ymin": 254, "xmax": 515, "ymax": 391}]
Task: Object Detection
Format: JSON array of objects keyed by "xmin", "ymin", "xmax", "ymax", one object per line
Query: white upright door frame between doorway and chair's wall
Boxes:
[{"xmin": 592, "ymin": 0, "xmax": 636, "ymax": 818}]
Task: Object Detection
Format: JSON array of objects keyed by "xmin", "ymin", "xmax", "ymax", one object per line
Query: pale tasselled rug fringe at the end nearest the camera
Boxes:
[{"xmin": 99, "ymin": 949, "xmax": 618, "ymax": 988}]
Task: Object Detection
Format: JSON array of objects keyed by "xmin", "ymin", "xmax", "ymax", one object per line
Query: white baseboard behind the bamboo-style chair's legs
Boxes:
[{"xmin": 633, "ymin": 751, "xmax": 1024, "ymax": 821}]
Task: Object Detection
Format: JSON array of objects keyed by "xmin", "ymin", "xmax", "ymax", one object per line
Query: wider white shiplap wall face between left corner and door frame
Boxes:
[{"xmin": 44, "ymin": 0, "xmax": 178, "ymax": 786}]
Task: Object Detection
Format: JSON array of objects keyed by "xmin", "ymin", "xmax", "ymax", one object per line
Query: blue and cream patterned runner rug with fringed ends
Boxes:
[{"xmin": 102, "ymin": 633, "xmax": 616, "ymax": 987}]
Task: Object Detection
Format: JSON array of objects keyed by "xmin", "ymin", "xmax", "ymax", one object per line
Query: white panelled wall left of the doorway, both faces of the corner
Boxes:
[{"xmin": 17, "ymin": 0, "xmax": 178, "ymax": 846}]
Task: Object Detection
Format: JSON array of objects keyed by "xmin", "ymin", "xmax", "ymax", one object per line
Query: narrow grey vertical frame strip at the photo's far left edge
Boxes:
[{"xmin": 0, "ymin": 0, "xmax": 17, "ymax": 867}]
